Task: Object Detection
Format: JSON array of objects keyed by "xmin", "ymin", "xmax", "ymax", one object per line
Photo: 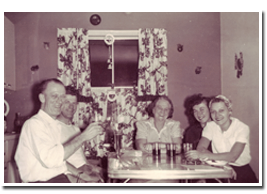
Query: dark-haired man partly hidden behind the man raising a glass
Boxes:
[{"xmin": 57, "ymin": 86, "xmax": 102, "ymax": 182}]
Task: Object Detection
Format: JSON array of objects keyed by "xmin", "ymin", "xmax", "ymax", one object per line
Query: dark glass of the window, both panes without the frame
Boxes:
[{"xmin": 89, "ymin": 40, "xmax": 138, "ymax": 87}]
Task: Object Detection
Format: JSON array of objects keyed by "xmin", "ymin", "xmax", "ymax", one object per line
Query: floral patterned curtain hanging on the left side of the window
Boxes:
[{"xmin": 57, "ymin": 28, "xmax": 92, "ymax": 127}]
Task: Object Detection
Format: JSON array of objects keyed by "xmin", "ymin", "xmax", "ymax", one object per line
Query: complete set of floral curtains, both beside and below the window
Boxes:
[{"xmin": 57, "ymin": 28, "xmax": 167, "ymax": 156}]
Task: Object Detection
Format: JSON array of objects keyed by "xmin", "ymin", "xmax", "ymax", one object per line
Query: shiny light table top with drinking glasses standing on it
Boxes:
[{"xmin": 108, "ymin": 153, "xmax": 232, "ymax": 179}]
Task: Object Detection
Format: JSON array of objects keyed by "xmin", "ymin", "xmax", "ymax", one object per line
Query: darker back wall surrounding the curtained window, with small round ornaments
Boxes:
[{"xmin": 5, "ymin": 12, "xmax": 221, "ymax": 133}]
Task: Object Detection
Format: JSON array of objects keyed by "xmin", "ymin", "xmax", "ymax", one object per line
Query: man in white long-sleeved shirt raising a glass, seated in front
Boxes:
[{"xmin": 15, "ymin": 79, "xmax": 102, "ymax": 183}]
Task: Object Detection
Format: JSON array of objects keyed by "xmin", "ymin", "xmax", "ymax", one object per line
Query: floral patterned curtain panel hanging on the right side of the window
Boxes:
[{"xmin": 138, "ymin": 28, "xmax": 168, "ymax": 96}]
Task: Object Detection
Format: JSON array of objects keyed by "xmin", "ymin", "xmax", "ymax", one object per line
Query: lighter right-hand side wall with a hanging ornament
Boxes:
[{"xmin": 221, "ymin": 12, "xmax": 259, "ymax": 177}]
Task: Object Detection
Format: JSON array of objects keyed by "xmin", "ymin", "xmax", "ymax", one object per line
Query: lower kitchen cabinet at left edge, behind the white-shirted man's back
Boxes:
[{"xmin": 4, "ymin": 134, "xmax": 21, "ymax": 183}]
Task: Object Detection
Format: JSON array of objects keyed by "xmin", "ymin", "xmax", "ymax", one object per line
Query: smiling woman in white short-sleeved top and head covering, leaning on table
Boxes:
[{"xmin": 186, "ymin": 95, "xmax": 258, "ymax": 183}]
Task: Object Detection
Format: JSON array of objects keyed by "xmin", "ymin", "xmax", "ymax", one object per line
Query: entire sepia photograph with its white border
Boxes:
[{"xmin": 1, "ymin": 1, "xmax": 266, "ymax": 190}]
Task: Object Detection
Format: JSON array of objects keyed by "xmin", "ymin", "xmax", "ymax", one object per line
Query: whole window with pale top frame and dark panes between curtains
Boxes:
[{"xmin": 89, "ymin": 31, "xmax": 139, "ymax": 87}]
